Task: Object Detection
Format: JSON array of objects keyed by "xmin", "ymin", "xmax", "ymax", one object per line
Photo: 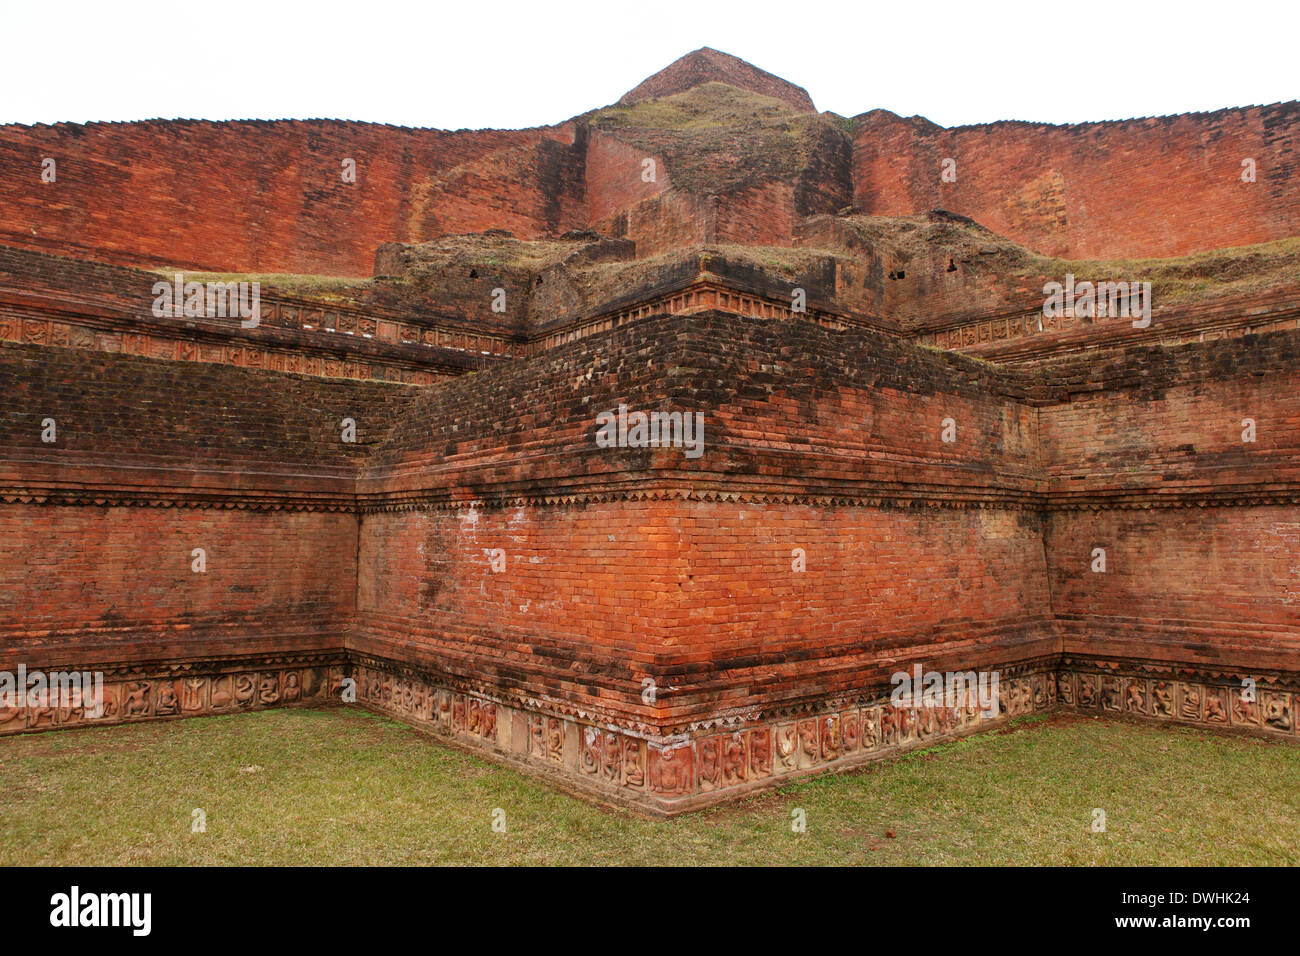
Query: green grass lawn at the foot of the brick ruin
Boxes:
[{"xmin": 0, "ymin": 709, "xmax": 1300, "ymax": 865}]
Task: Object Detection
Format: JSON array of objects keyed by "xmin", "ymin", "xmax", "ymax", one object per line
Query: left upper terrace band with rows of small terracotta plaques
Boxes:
[{"xmin": 0, "ymin": 243, "xmax": 533, "ymax": 385}]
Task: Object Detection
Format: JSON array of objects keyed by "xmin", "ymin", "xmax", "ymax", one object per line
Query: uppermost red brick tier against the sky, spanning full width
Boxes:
[{"xmin": 0, "ymin": 51, "xmax": 1300, "ymax": 276}]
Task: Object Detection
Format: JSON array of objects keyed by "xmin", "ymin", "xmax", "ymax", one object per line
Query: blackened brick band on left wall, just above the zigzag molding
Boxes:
[{"xmin": 0, "ymin": 342, "xmax": 413, "ymax": 481}]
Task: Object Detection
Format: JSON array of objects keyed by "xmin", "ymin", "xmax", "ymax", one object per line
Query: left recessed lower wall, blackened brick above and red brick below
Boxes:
[{"xmin": 0, "ymin": 343, "xmax": 411, "ymax": 665}]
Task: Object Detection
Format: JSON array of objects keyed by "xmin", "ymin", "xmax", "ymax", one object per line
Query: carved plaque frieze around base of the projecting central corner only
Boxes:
[{"xmin": 354, "ymin": 657, "xmax": 1056, "ymax": 816}]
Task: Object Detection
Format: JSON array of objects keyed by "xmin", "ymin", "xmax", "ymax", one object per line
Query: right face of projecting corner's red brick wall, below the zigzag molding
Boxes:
[{"xmin": 663, "ymin": 502, "xmax": 1057, "ymax": 710}]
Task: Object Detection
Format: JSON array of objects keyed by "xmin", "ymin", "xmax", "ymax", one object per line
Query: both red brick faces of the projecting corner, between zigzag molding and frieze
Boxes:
[{"xmin": 348, "ymin": 501, "xmax": 1058, "ymax": 717}]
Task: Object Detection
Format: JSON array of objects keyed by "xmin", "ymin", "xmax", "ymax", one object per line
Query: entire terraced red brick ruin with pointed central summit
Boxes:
[{"xmin": 0, "ymin": 49, "xmax": 1300, "ymax": 814}]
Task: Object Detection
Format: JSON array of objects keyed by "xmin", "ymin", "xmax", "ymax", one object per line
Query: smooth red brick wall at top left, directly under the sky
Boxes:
[{"xmin": 0, "ymin": 120, "xmax": 573, "ymax": 276}]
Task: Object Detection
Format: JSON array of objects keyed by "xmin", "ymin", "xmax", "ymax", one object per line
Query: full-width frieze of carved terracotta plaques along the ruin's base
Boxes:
[{"xmin": 0, "ymin": 642, "xmax": 1300, "ymax": 817}]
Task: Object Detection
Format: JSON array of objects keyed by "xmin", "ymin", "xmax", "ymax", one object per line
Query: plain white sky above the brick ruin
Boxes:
[{"xmin": 0, "ymin": 0, "xmax": 1300, "ymax": 129}]
